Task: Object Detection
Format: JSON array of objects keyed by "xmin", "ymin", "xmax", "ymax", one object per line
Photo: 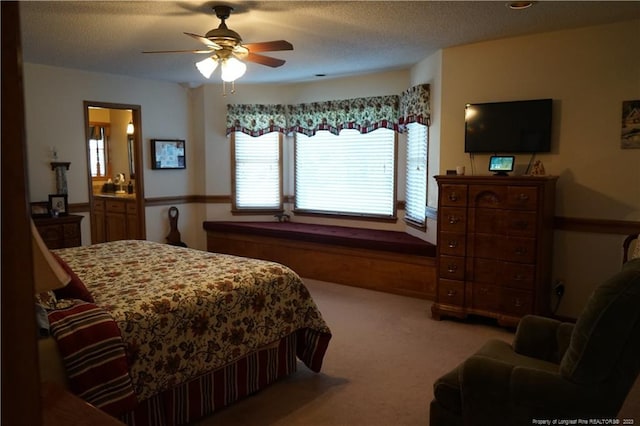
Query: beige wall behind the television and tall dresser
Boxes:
[{"xmin": 429, "ymin": 20, "xmax": 640, "ymax": 316}]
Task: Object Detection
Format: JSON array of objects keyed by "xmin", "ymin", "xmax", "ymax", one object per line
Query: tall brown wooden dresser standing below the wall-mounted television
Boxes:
[{"xmin": 431, "ymin": 175, "xmax": 557, "ymax": 326}]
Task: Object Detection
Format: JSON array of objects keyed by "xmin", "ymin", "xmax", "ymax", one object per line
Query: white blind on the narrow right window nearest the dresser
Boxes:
[{"xmin": 405, "ymin": 123, "xmax": 427, "ymax": 226}]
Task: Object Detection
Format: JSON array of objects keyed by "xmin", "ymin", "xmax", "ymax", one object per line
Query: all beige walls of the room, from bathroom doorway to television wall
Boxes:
[{"xmin": 25, "ymin": 21, "xmax": 640, "ymax": 316}]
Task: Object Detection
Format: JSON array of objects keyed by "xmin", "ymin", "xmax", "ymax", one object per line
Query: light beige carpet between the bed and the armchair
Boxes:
[{"xmin": 196, "ymin": 279, "xmax": 640, "ymax": 426}]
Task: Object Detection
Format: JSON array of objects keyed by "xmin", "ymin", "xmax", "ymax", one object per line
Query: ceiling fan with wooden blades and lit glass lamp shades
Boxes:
[{"xmin": 142, "ymin": 5, "xmax": 293, "ymax": 81}]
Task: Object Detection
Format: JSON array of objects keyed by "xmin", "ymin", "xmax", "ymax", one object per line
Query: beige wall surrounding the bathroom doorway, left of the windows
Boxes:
[{"xmin": 24, "ymin": 63, "xmax": 192, "ymax": 244}]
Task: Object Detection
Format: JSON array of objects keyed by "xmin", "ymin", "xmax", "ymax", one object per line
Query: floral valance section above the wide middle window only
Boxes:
[{"xmin": 289, "ymin": 95, "xmax": 400, "ymax": 136}]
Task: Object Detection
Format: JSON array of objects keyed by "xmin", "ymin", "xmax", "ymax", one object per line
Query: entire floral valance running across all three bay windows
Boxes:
[{"xmin": 227, "ymin": 84, "xmax": 430, "ymax": 136}]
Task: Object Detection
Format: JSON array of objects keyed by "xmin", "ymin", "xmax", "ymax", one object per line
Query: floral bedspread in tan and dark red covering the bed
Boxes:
[{"xmin": 56, "ymin": 240, "xmax": 330, "ymax": 400}]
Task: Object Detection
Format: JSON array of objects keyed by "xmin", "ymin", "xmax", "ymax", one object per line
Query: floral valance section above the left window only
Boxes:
[{"xmin": 227, "ymin": 104, "xmax": 288, "ymax": 137}]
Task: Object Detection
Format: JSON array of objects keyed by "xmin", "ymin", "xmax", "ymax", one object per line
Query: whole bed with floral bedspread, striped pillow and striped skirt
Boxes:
[{"xmin": 40, "ymin": 240, "xmax": 331, "ymax": 425}]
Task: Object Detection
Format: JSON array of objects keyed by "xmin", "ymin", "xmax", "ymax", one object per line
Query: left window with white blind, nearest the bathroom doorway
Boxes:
[{"xmin": 231, "ymin": 132, "xmax": 282, "ymax": 212}]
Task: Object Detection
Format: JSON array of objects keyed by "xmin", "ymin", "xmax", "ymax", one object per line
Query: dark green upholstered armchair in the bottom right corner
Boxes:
[{"xmin": 430, "ymin": 259, "xmax": 640, "ymax": 426}]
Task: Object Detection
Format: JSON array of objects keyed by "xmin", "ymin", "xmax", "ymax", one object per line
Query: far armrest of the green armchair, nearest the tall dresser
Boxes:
[{"xmin": 513, "ymin": 315, "xmax": 562, "ymax": 362}]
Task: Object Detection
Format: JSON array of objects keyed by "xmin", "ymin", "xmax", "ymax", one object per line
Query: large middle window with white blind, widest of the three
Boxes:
[{"xmin": 295, "ymin": 128, "xmax": 396, "ymax": 218}]
